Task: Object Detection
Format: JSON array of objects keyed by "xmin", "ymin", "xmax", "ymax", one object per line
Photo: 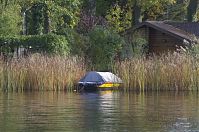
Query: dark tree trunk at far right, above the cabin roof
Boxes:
[{"xmin": 187, "ymin": 0, "xmax": 199, "ymax": 22}]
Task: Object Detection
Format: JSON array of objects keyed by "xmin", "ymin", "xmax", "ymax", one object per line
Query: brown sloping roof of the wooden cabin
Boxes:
[{"xmin": 125, "ymin": 21, "xmax": 199, "ymax": 42}]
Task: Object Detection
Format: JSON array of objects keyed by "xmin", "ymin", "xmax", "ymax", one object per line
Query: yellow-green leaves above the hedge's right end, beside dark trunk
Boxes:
[{"xmin": 46, "ymin": 0, "xmax": 81, "ymax": 31}]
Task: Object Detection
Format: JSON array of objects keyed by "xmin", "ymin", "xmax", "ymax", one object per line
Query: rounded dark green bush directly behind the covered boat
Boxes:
[{"xmin": 88, "ymin": 26, "xmax": 124, "ymax": 70}]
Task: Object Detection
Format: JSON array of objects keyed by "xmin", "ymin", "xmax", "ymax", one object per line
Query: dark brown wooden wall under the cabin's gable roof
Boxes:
[{"xmin": 148, "ymin": 27, "xmax": 183, "ymax": 54}]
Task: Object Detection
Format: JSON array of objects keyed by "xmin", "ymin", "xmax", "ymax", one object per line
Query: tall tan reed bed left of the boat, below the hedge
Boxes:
[{"xmin": 0, "ymin": 55, "xmax": 85, "ymax": 91}]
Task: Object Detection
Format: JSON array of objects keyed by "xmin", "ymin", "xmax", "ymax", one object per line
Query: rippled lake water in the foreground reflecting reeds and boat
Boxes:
[{"xmin": 0, "ymin": 91, "xmax": 199, "ymax": 132}]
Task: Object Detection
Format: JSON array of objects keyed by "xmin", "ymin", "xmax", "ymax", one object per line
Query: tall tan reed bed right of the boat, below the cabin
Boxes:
[{"xmin": 115, "ymin": 53, "xmax": 199, "ymax": 91}]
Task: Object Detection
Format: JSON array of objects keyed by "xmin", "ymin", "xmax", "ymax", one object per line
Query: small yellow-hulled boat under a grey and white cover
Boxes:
[{"xmin": 78, "ymin": 71, "xmax": 122, "ymax": 90}]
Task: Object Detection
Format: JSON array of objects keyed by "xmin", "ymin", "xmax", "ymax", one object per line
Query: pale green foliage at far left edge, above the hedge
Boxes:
[{"xmin": 0, "ymin": 5, "xmax": 21, "ymax": 35}]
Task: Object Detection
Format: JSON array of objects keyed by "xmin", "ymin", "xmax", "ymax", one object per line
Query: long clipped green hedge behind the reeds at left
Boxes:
[{"xmin": 0, "ymin": 34, "xmax": 69, "ymax": 55}]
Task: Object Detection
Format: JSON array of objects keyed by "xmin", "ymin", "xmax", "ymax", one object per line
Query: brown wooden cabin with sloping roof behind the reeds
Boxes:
[{"xmin": 123, "ymin": 21, "xmax": 199, "ymax": 54}]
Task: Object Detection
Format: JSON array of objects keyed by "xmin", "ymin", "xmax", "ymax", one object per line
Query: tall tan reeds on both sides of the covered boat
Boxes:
[{"xmin": 0, "ymin": 53, "xmax": 199, "ymax": 92}]
